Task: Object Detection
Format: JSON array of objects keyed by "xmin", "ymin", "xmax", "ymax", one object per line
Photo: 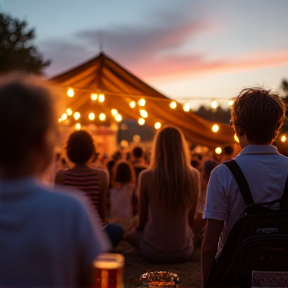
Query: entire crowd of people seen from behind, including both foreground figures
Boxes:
[{"xmin": 0, "ymin": 75, "xmax": 288, "ymax": 287}]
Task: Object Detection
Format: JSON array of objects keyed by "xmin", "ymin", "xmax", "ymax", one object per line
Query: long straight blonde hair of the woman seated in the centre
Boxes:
[{"xmin": 150, "ymin": 126, "xmax": 198, "ymax": 211}]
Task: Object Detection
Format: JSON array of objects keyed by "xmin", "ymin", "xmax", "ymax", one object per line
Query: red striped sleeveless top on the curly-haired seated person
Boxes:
[{"xmin": 63, "ymin": 169, "xmax": 102, "ymax": 211}]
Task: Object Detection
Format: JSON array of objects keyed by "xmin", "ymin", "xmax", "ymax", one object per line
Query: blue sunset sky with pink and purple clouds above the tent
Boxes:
[{"xmin": 0, "ymin": 0, "xmax": 288, "ymax": 109}]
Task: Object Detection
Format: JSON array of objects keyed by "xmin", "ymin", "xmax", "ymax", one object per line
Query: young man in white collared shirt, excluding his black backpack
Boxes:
[{"xmin": 202, "ymin": 88, "xmax": 288, "ymax": 284}]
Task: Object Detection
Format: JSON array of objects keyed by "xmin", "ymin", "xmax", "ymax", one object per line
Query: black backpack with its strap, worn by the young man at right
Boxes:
[{"xmin": 205, "ymin": 160, "xmax": 288, "ymax": 288}]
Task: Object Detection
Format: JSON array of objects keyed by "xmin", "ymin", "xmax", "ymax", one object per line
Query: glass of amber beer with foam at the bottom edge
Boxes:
[{"xmin": 93, "ymin": 253, "xmax": 124, "ymax": 288}]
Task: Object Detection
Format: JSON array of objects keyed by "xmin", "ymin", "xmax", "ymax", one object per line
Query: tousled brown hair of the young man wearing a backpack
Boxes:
[{"xmin": 231, "ymin": 87, "xmax": 286, "ymax": 145}]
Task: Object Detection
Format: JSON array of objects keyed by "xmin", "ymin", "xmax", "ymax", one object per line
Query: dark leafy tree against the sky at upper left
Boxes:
[{"xmin": 0, "ymin": 13, "xmax": 50, "ymax": 74}]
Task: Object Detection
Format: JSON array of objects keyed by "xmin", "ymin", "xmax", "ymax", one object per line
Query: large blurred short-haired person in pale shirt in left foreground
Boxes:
[{"xmin": 0, "ymin": 75, "xmax": 110, "ymax": 287}]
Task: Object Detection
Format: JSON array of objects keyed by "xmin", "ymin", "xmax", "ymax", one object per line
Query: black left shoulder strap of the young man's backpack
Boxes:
[{"xmin": 223, "ymin": 159, "xmax": 254, "ymax": 206}]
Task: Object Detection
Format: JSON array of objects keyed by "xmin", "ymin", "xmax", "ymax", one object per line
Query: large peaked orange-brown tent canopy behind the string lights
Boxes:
[{"xmin": 50, "ymin": 53, "xmax": 234, "ymax": 148}]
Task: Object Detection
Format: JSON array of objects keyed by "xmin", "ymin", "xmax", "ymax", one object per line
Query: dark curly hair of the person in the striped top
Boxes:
[{"xmin": 66, "ymin": 130, "xmax": 96, "ymax": 164}]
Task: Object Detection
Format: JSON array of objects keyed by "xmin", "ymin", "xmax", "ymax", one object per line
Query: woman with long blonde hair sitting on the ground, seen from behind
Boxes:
[{"xmin": 126, "ymin": 126, "xmax": 200, "ymax": 263}]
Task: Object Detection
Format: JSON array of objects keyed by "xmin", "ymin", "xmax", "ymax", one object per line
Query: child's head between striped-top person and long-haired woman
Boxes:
[{"xmin": 113, "ymin": 161, "xmax": 135, "ymax": 183}]
